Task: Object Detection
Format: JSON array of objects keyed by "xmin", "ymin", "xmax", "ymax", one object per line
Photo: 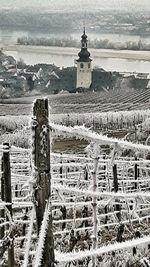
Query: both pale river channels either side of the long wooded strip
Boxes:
[{"xmin": 0, "ymin": 28, "xmax": 150, "ymax": 73}]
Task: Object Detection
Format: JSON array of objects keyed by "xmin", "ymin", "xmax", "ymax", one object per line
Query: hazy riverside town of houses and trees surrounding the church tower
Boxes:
[{"xmin": 0, "ymin": 47, "xmax": 150, "ymax": 99}]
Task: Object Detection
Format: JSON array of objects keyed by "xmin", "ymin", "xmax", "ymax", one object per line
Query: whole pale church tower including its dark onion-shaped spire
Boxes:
[{"xmin": 76, "ymin": 27, "xmax": 92, "ymax": 88}]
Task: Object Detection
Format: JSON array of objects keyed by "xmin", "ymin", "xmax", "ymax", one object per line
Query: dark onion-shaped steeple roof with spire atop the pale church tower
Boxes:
[{"xmin": 77, "ymin": 27, "xmax": 92, "ymax": 62}]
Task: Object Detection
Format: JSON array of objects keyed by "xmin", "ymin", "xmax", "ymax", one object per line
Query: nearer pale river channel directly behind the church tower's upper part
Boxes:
[{"xmin": 3, "ymin": 48, "xmax": 150, "ymax": 73}]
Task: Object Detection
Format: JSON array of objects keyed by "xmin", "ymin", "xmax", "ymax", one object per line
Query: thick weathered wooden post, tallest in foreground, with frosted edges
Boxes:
[{"xmin": 33, "ymin": 99, "xmax": 55, "ymax": 267}]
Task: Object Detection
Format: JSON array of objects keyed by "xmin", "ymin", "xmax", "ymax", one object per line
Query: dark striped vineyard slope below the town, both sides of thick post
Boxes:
[{"xmin": 0, "ymin": 89, "xmax": 150, "ymax": 115}]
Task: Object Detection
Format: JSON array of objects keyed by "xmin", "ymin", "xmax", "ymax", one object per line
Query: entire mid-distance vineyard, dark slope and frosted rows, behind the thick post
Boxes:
[{"xmin": 0, "ymin": 89, "xmax": 150, "ymax": 147}]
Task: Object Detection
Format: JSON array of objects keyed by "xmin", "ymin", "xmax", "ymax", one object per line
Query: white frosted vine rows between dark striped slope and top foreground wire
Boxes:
[{"xmin": 0, "ymin": 110, "xmax": 150, "ymax": 148}]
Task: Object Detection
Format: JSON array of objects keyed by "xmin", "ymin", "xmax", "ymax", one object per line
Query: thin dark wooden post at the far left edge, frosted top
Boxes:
[{"xmin": 3, "ymin": 143, "xmax": 14, "ymax": 267}]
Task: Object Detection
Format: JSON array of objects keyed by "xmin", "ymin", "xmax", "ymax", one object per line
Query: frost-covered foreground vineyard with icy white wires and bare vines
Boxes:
[{"xmin": 0, "ymin": 100, "xmax": 150, "ymax": 267}]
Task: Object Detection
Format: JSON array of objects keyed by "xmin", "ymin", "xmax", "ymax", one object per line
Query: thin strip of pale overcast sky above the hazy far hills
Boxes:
[{"xmin": 0, "ymin": 0, "xmax": 150, "ymax": 11}]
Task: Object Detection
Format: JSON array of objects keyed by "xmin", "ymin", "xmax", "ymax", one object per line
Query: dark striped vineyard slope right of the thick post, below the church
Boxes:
[{"xmin": 50, "ymin": 89, "xmax": 150, "ymax": 113}]
